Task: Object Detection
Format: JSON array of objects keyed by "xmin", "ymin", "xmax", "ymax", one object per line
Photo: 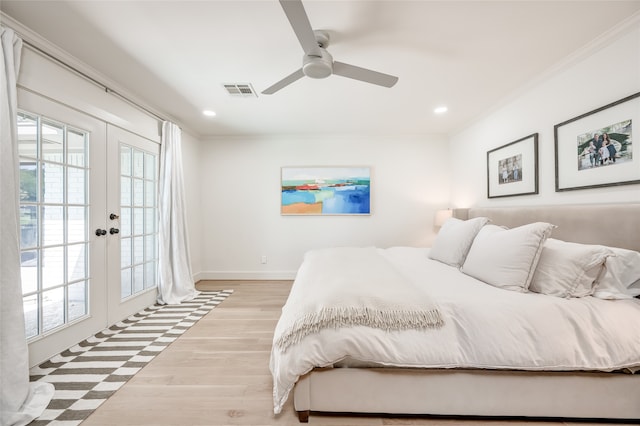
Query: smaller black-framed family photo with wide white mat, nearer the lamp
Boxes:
[{"xmin": 487, "ymin": 133, "xmax": 538, "ymax": 198}]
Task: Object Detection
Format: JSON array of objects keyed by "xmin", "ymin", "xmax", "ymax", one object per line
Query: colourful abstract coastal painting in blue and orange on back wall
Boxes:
[{"xmin": 280, "ymin": 167, "xmax": 371, "ymax": 215}]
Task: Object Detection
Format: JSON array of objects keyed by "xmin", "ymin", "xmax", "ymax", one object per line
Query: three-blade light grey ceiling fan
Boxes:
[{"xmin": 262, "ymin": 0, "xmax": 398, "ymax": 95}]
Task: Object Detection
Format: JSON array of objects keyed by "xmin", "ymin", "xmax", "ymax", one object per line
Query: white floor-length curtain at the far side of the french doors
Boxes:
[{"xmin": 158, "ymin": 121, "xmax": 199, "ymax": 304}]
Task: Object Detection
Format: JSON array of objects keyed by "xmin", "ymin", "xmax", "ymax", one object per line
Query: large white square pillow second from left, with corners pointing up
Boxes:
[{"xmin": 461, "ymin": 222, "xmax": 555, "ymax": 292}]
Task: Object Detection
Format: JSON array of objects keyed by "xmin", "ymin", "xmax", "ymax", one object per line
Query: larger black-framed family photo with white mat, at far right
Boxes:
[{"xmin": 554, "ymin": 92, "xmax": 640, "ymax": 192}]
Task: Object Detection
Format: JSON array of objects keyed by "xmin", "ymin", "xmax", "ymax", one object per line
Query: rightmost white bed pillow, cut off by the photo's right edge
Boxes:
[{"xmin": 593, "ymin": 247, "xmax": 640, "ymax": 299}]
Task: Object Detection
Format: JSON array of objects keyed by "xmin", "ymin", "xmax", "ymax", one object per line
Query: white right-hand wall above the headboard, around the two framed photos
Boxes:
[{"xmin": 450, "ymin": 24, "xmax": 640, "ymax": 207}]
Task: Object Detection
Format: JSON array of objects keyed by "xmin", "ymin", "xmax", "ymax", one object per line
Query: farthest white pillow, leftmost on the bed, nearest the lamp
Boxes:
[{"xmin": 428, "ymin": 217, "xmax": 489, "ymax": 268}]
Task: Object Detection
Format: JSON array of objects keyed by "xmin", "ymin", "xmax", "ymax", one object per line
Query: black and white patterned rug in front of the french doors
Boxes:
[{"xmin": 29, "ymin": 290, "xmax": 233, "ymax": 426}]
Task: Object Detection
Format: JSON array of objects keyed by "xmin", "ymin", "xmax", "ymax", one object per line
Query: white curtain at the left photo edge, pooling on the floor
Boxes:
[{"xmin": 0, "ymin": 27, "xmax": 54, "ymax": 426}]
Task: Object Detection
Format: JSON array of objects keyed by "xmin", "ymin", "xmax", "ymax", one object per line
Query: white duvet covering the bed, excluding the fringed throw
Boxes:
[{"xmin": 270, "ymin": 247, "xmax": 640, "ymax": 413}]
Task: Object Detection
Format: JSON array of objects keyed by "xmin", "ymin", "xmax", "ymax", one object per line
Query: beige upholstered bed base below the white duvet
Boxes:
[{"xmin": 294, "ymin": 368, "xmax": 640, "ymax": 424}]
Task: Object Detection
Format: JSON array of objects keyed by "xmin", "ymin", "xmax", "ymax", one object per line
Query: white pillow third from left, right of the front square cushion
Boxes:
[{"xmin": 529, "ymin": 238, "xmax": 613, "ymax": 298}]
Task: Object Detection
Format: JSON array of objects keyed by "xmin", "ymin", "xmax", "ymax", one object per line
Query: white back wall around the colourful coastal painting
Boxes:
[{"xmin": 197, "ymin": 135, "xmax": 449, "ymax": 279}]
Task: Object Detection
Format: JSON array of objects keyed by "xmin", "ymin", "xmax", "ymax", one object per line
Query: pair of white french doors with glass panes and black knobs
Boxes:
[{"xmin": 17, "ymin": 89, "xmax": 158, "ymax": 366}]
